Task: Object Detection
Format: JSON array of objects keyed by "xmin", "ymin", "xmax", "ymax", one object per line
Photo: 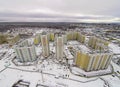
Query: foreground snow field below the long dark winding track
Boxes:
[{"xmin": 0, "ymin": 69, "xmax": 103, "ymax": 87}]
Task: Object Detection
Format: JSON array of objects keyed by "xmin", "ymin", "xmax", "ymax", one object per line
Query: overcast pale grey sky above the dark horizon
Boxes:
[{"xmin": 0, "ymin": 0, "xmax": 120, "ymax": 22}]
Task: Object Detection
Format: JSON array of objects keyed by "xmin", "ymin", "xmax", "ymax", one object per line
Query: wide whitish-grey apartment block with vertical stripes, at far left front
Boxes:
[{"xmin": 14, "ymin": 46, "xmax": 37, "ymax": 62}]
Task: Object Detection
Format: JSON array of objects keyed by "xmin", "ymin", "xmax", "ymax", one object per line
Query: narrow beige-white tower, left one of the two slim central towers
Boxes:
[{"xmin": 41, "ymin": 34, "xmax": 50, "ymax": 57}]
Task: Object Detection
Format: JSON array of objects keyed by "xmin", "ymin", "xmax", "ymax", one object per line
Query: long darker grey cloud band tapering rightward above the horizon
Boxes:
[{"xmin": 0, "ymin": 11, "xmax": 114, "ymax": 19}]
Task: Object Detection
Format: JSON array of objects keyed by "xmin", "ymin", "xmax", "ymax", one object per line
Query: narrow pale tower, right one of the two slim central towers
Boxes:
[{"xmin": 56, "ymin": 37, "xmax": 64, "ymax": 60}]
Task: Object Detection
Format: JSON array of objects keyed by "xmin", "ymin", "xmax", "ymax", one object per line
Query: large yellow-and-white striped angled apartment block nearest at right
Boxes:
[{"xmin": 75, "ymin": 48, "xmax": 113, "ymax": 71}]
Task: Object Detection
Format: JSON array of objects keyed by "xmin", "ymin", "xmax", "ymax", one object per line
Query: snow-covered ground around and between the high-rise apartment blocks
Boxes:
[{"xmin": 0, "ymin": 39, "xmax": 120, "ymax": 87}]
